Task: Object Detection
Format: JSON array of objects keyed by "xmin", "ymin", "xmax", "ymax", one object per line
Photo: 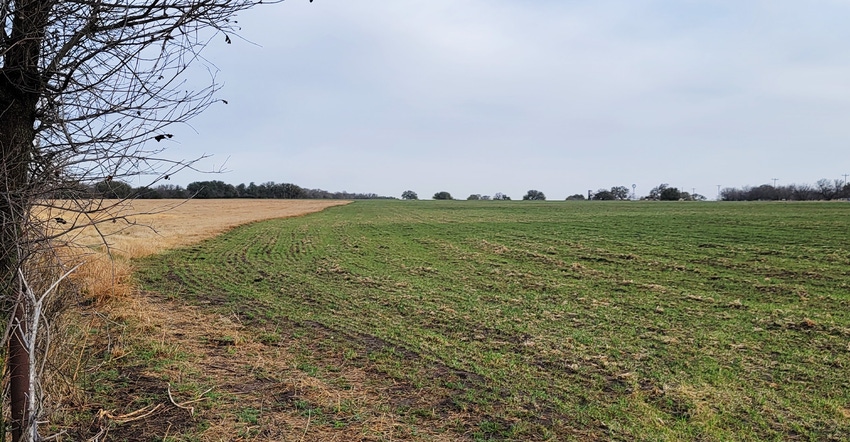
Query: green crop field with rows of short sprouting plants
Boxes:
[{"xmin": 139, "ymin": 201, "xmax": 850, "ymax": 441}]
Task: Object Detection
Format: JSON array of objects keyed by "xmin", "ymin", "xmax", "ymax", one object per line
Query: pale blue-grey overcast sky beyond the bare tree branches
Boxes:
[{"xmin": 164, "ymin": 0, "xmax": 850, "ymax": 199}]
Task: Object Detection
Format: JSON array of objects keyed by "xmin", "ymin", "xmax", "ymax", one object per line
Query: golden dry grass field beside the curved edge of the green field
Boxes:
[{"xmin": 52, "ymin": 199, "xmax": 348, "ymax": 302}]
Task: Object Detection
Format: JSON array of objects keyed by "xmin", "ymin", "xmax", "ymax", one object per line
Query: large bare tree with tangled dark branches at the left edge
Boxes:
[{"xmin": 0, "ymin": 0, "xmax": 298, "ymax": 442}]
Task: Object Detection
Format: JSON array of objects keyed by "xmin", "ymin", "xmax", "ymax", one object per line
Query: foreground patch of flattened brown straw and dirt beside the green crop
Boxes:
[{"xmin": 76, "ymin": 294, "xmax": 469, "ymax": 441}]
